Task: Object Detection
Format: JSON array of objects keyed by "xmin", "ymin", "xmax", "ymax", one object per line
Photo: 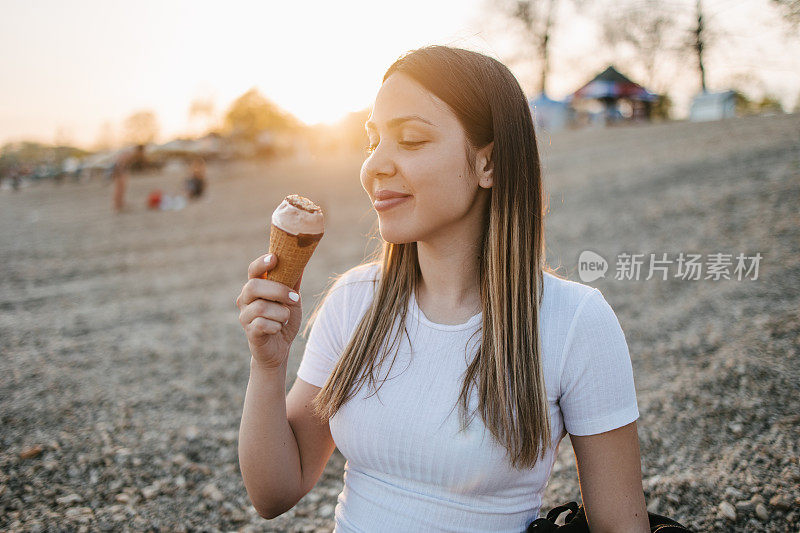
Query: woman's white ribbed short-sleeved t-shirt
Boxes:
[{"xmin": 297, "ymin": 263, "xmax": 639, "ymax": 533}]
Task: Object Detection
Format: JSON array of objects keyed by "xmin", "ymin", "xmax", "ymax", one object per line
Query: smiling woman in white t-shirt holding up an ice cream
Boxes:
[{"xmin": 237, "ymin": 46, "xmax": 649, "ymax": 533}]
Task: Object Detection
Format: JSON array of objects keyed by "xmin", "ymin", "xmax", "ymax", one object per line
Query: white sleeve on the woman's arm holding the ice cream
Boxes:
[{"xmin": 297, "ymin": 276, "xmax": 348, "ymax": 387}]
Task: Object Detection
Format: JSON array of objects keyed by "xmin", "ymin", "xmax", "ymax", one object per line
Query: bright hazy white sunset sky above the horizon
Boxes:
[{"xmin": 0, "ymin": 0, "xmax": 800, "ymax": 148}]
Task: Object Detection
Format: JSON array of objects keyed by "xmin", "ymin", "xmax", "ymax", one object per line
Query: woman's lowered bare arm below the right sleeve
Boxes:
[{"xmin": 570, "ymin": 421, "xmax": 650, "ymax": 533}]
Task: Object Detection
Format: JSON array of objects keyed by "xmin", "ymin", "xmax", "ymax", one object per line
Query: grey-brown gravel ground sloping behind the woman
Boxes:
[{"xmin": 0, "ymin": 114, "xmax": 800, "ymax": 532}]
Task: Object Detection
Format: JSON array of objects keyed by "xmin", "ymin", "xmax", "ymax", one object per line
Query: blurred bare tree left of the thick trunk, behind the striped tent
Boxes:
[{"xmin": 598, "ymin": 0, "xmax": 677, "ymax": 92}]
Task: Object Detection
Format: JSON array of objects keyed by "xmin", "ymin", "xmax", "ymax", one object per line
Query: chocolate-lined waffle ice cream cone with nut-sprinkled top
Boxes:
[{"xmin": 264, "ymin": 194, "xmax": 325, "ymax": 289}]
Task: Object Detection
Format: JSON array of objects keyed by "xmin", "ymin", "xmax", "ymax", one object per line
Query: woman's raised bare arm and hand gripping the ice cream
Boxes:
[{"xmin": 236, "ymin": 255, "xmax": 335, "ymax": 518}]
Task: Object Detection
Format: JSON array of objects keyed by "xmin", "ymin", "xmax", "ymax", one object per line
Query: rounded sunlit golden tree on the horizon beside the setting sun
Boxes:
[{"xmin": 225, "ymin": 87, "xmax": 301, "ymax": 141}]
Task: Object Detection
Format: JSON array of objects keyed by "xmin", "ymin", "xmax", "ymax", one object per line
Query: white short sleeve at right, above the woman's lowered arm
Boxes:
[{"xmin": 559, "ymin": 288, "xmax": 639, "ymax": 436}]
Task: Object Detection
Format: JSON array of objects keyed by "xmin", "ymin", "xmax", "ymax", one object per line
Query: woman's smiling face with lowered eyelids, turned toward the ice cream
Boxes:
[{"xmin": 361, "ymin": 73, "xmax": 483, "ymax": 244}]
